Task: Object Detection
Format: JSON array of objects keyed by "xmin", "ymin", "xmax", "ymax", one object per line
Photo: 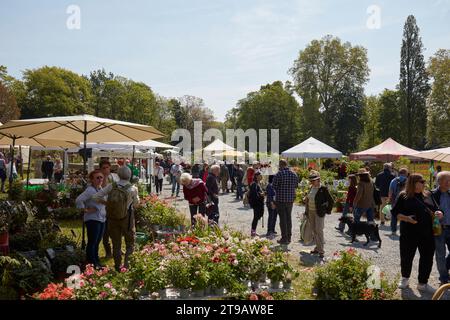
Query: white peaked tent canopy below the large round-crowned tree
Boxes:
[{"xmin": 281, "ymin": 137, "xmax": 342, "ymax": 159}]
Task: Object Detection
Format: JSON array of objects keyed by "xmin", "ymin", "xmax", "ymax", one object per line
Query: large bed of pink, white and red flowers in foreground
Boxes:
[{"xmin": 35, "ymin": 222, "xmax": 296, "ymax": 300}]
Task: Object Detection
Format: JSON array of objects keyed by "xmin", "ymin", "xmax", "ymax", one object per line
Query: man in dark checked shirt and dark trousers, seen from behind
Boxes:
[{"xmin": 273, "ymin": 160, "xmax": 298, "ymax": 245}]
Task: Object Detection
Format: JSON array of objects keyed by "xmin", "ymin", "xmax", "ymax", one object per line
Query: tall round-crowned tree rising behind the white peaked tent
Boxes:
[{"xmin": 289, "ymin": 35, "xmax": 369, "ymax": 146}]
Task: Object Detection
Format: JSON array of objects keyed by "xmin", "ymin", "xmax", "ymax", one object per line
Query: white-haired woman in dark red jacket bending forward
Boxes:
[{"xmin": 180, "ymin": 173, "xmax": 208, "ymax": 226}]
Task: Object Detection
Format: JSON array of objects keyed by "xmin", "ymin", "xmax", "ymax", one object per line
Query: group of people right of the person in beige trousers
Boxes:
[{"xmin": 328, "ymin": 163, "xmax": 450, "ymax": 292}]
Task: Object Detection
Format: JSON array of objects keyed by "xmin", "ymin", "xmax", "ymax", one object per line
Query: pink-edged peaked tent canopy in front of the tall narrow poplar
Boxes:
[{"xmin": 350, "ymin": 138, "xmax": 417, "ymax": 161}]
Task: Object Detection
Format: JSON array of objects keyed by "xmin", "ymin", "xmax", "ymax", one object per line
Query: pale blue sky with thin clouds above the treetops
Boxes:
[{"xmin": 0, "ymin": 0, "xmax": 450, "ymax": 120}]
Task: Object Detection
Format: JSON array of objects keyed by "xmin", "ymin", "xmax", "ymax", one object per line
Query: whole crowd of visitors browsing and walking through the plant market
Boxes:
[{"xmin": 44, "ymin": 151, "xmax": 450, "ymax": 291}]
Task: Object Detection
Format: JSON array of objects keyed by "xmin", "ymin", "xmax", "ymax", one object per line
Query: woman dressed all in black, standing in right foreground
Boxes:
[{"xmin": 392, "ymin": 174, "xmax": 443, "ymax": 293}]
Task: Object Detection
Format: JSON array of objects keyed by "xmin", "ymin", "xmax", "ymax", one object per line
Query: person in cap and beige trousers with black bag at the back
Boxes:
[{"xmin": 304, "ymin": 170, "xmax": 334, "ymax": 258}]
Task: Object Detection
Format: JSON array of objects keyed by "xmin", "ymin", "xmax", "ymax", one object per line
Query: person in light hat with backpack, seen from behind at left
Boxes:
[{"xmin": 93, "ymin": 166, "xmax": 139, "ymax": 271}]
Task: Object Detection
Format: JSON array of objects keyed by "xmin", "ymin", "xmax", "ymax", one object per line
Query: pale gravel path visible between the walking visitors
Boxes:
[{"xmin": 161, "ymin": 185, "xmax": 450, "ymax": 300}]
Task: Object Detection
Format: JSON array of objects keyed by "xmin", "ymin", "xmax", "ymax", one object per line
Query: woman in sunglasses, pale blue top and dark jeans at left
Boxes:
[{"xmin": 75, "ymin": 170, "xmax": 106, "ymax": 268}]
